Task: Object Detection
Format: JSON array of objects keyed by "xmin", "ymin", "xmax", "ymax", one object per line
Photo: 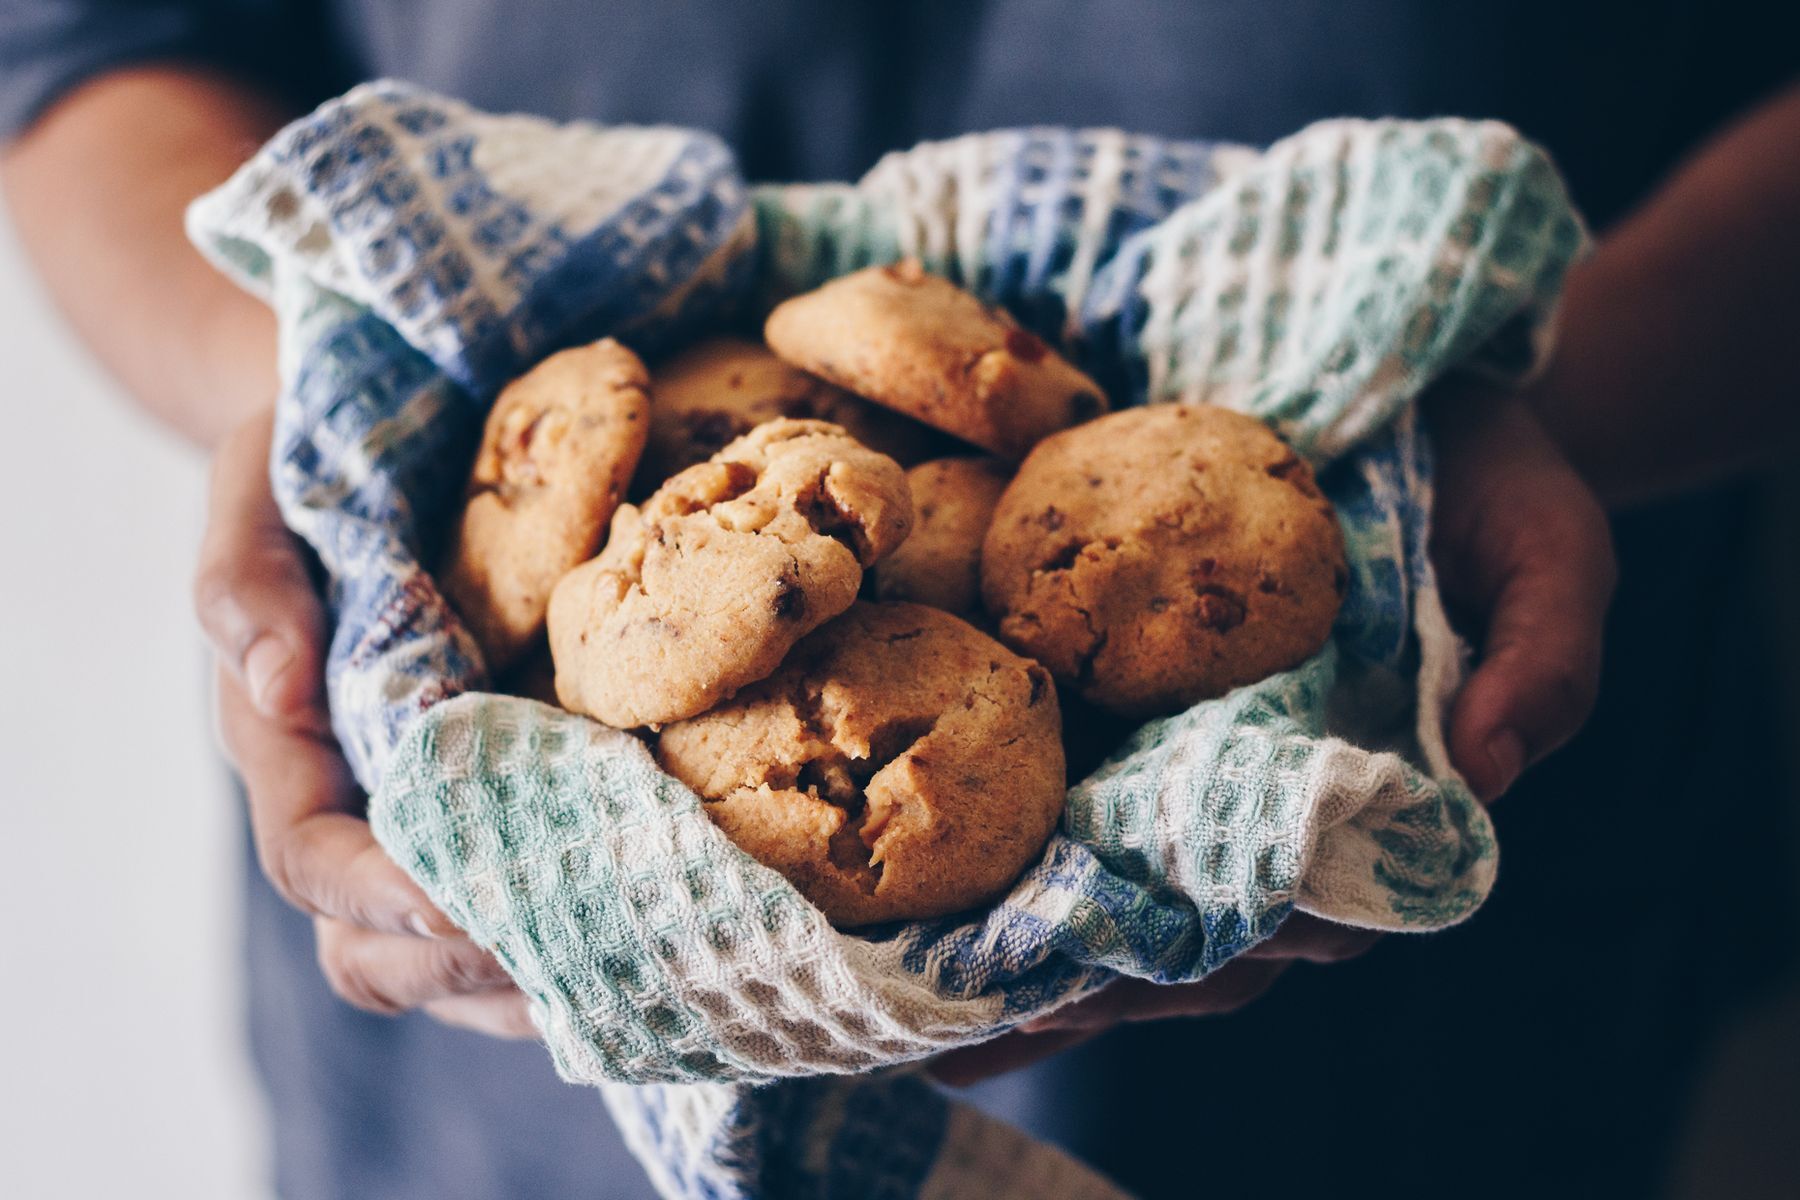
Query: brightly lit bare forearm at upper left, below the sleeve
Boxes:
[{"xmin": 0, "ymin": 68, "xmax": 284, "ymax": 444}]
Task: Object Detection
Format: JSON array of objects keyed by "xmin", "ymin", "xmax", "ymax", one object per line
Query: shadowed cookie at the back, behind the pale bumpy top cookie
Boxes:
[{"xmin": 637, "ymin": 338, "xmax": 934, "ymax": 491}]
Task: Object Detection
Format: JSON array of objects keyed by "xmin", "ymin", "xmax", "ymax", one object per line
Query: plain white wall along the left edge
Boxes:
[{"xmin": 0, "ymin": 201, "xmax": 266, "ymax": 1200}]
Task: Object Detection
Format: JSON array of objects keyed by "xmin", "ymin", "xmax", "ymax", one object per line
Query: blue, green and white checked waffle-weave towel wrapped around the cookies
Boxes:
[{"xmin": 189, "ymin": 83, "xmax": 1584, "ymax": 1196}]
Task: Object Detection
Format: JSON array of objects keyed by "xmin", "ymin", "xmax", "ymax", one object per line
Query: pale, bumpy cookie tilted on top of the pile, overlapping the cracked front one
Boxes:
[{"xmin": 549, "ymin": 419, "xmax": 913, "ymax": 729}]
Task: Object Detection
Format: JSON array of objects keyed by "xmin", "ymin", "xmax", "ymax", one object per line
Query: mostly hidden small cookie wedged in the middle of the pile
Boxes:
[{"xmin": 875, "ymin": 459, "xmax": 1012, "ymax": 619}]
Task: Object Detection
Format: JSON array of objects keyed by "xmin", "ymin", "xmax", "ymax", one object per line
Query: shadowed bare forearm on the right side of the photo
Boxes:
[{"xmin": 1530, "ymin": 80, "xmax": 1800, "ymax": 506}]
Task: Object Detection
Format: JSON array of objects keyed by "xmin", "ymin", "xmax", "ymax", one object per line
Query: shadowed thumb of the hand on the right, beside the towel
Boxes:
[{"xmin": 1449, "ymin": 479, "xmax": 1615, "ymax": 801}]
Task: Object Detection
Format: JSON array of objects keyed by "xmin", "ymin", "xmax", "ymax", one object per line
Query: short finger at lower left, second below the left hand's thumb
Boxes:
[{"xmin": 313, "ymin": 918, "xmax": 522, "ymax": 1016}]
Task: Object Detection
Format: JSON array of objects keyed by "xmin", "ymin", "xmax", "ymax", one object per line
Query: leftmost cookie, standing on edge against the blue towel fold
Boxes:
[{"xmin": 439, "ymin": 338, "xmax": 650, "ymax": 673}]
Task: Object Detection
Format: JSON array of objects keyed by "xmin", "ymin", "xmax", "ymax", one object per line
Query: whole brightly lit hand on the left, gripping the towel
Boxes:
[{"xmin": 194, "ymin": 414, "xmax": 536, "ymax": 1038}]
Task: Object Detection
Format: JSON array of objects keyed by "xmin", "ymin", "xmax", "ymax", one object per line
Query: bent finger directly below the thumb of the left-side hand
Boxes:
[{"xmin": 218, "ymin": 669, "xmax": 459, "ymax": 937}]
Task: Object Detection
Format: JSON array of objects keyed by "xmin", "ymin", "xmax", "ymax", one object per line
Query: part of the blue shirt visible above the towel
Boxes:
[{"xmin": 0, "ymin": 0, "xmax": 1800, "ymax": 223}]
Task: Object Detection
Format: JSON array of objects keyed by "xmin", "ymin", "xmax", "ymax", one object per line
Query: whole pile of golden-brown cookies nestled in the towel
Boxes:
[{"xmin": 441, "ymin": 261, "xmax": 1346, "ymax": 928}]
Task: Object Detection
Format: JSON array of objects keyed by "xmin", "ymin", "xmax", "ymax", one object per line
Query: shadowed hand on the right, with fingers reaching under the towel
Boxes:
[{"xmin": 931, "ymin": 383, "xmax": 1616, "ymax": 1087}]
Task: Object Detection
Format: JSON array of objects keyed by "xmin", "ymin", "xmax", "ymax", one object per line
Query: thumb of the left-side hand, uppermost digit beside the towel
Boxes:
[{"xmin": 194, "ymin": 412, "xmax": 326, "ymax": 727}]
